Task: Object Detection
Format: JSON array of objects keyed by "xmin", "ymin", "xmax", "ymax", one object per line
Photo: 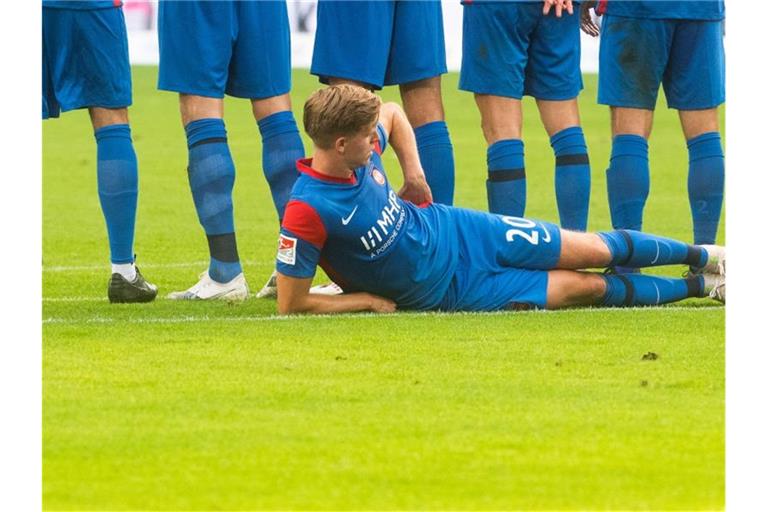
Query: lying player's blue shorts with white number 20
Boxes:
[{"xmin": 439, "ymin": 208, "xmax": 561, "ymax": 311}]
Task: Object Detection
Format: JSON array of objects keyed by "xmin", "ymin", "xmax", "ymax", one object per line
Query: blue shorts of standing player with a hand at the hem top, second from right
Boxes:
[{"xmin": 459, "ymin": 2, "xmax": 583, "ymax": 101}]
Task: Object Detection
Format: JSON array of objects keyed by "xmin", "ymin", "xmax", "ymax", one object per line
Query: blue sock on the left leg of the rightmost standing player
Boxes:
[{"xmin": 606, "ymin": 135, "xmax": 650, "ymax": 231}]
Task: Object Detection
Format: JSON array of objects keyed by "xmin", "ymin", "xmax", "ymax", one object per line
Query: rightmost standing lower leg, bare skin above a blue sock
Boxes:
[{"xmin": 680, "ymin": 108, "xmax": 725, "ymax": 244}]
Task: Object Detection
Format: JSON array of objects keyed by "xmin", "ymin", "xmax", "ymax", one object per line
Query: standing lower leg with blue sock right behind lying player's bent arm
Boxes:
[{"xmin": 400, "ymin": 76, "xmax": 455, "ymax": 206}]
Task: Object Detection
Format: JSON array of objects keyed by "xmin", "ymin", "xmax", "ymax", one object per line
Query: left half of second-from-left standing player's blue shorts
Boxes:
[{"xmin": 157, "ymin": 0, "xmax": 231, "ymax": 98}]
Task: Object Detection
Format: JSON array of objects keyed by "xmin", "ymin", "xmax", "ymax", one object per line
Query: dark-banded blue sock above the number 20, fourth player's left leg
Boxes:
[{"xmin": 486, "ymin": 139, "xmax": 525, "ymax": 217}]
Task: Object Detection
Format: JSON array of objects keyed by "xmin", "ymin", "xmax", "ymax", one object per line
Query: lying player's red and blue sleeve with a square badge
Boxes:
[{"xmin": 276, "ymin": 200, "xmax": 327, "ymax": 279}]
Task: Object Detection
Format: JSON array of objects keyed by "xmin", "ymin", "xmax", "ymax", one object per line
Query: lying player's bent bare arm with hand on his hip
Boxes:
[{"xmin": 379, "ymin": 103, "xmax": 432, "ymax": 204}]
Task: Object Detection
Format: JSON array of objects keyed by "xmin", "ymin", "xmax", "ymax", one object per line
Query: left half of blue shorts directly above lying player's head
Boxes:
[{"xmin": 310, "ymin": 0, "xmax": 395, "ymax": 89}]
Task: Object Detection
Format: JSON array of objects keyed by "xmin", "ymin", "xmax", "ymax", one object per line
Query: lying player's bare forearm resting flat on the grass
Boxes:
[{"xmin": 277, "ymin": 272, "xmax": 396, "ymax": 315}]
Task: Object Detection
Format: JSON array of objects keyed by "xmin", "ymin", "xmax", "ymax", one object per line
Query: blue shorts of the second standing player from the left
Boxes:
[{"xmin": 158, "ymin": 0, "xmax": 291, "ymax": 99}]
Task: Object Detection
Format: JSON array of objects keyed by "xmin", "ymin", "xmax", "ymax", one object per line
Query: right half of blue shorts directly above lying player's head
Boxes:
[{"xmin": 384, "ymin": 2, "xmax": 448, "ymax": 85}]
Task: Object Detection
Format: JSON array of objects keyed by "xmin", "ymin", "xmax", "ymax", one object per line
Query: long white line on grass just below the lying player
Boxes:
[{"xmin": 43, "ymin": 306, "xmax": 721, "ymax": 325}]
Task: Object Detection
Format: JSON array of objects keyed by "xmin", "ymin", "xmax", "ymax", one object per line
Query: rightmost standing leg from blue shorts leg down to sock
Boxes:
[{"xmin": 664, "ymin": 20, "xmax": 725, "ymax": 244}]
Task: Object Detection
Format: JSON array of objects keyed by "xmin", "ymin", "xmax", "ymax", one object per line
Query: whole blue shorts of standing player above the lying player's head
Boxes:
[{"xmin": 311, "ymin": 0, "xmax": 447, "ymax": 89}]
